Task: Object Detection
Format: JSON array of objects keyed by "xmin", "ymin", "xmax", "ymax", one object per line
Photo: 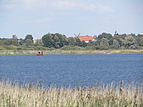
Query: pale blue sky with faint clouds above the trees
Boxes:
[{"xmin": 0, "ymin": 0, "xmax": 143, "ymax": 39}]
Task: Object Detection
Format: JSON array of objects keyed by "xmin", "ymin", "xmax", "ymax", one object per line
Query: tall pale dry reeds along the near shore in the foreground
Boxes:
[{"xmin": 0, "ymin": 82, "xmax": 143, "ymax": 107}]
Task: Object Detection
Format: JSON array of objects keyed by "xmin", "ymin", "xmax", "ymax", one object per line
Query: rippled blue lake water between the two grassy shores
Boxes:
[{"xmin": 0, "ymin": 54, "xmax": 143, "ymax": 87}]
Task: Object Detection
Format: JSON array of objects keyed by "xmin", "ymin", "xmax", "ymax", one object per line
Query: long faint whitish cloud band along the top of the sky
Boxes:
[{"xmin": 0, "ymin": 0, "xmax": 113, "ymax": 12}]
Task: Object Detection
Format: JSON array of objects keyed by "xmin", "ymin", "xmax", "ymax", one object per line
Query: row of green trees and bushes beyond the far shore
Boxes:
[{"xmin": 0, "ymin": 33, "xmax": 143, "ymax": 50}]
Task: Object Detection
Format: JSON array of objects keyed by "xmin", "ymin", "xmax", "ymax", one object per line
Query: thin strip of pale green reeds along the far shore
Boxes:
[{"xmin": 0, "ymin": 49, "xmax": 143, "ymax": 55}]
